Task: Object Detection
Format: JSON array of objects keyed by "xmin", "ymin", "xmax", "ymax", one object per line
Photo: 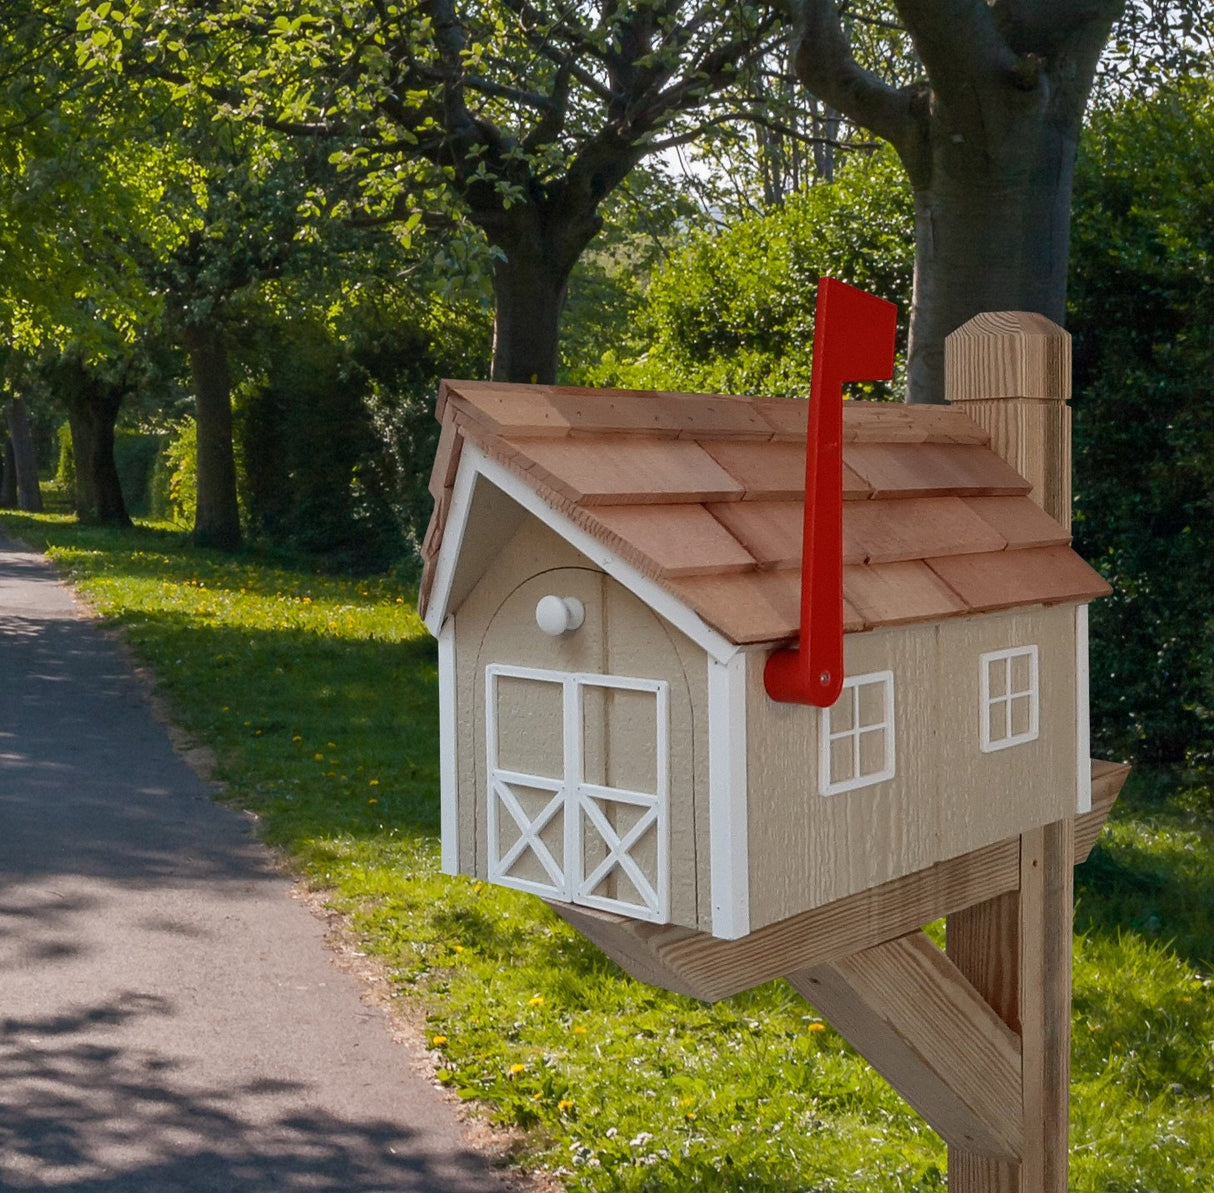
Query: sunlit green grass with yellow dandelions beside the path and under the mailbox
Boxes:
[{"xmin": 2, "ymin": 515, "xmax": 1214, "ymax": 1193}]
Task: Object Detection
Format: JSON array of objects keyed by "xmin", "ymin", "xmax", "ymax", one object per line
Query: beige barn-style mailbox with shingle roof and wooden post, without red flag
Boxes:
[{"xmin": 420, "ymin": 316, "xmax": 1124, "ymax": 1193}]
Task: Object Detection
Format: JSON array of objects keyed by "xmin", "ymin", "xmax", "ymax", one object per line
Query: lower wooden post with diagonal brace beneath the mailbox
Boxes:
[{"xmin": 789, "ymin": 820, "xmax": 1074, "ymax": 1193}]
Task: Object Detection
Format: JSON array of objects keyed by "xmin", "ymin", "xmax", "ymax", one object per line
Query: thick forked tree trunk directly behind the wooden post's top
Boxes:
[{"xmin": 793, "ymin": 0, "xmax": 1125, "ymax": 402}]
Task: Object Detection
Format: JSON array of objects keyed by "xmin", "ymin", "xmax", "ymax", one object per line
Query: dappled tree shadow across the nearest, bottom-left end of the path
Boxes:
[{"xmin": 0, "ymin": 994, "xmax": 488, "ymax": 1193}]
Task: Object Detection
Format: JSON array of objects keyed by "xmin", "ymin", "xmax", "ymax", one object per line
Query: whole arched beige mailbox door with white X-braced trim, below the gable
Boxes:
[{"xmin": 478, "ymin": 568, "xmax": 691, "ymax": 924}]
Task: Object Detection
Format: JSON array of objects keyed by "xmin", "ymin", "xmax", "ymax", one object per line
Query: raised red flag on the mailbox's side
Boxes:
[{"xmin": 764, "ymin": 278, "xmax": 897, "ymax": 708}]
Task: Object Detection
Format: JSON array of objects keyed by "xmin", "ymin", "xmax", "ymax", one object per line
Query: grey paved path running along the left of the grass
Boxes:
[{"xmin": 0, "ymin": 538, "xmax": 514, "ymax": 1193}]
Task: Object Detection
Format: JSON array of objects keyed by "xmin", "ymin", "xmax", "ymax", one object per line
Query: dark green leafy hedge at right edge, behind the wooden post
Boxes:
[{"xmin": 1070, "ymin": 78, "xmax": 1214, "ymax": 766}]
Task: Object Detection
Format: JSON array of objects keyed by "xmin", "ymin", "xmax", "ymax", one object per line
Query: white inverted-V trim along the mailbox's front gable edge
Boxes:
[{"xmin": 425, "ymin": 441, "xmax": 739, "ymax": 663}]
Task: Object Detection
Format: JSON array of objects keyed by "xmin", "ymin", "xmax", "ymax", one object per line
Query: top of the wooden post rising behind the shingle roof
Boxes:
[{"xmin": 944, "ymin": 311, "xmax": 1071, "ymax": 527}]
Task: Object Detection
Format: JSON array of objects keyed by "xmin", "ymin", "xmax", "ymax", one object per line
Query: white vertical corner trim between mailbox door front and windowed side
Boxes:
[{"xmin": 708, "ymin": 652, "xmax": 750, "ymax": 941}]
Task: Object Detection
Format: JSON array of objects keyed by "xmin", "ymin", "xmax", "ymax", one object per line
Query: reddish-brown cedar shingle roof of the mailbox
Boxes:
[{"xmin": 420, "ymin": 381, "xmax": 1110, "ymax": 644}]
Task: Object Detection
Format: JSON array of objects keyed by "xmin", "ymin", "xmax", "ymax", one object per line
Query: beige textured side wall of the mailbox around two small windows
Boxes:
[{"xmin": 747, "ymin": 606, "xmax": 1077, "ymax": 930}]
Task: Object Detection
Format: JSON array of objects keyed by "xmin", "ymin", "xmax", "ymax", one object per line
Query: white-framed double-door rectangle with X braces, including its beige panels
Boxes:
[{"xmin": 484, "ymin": 664, "xmax": 670, "ymax": 924}]
